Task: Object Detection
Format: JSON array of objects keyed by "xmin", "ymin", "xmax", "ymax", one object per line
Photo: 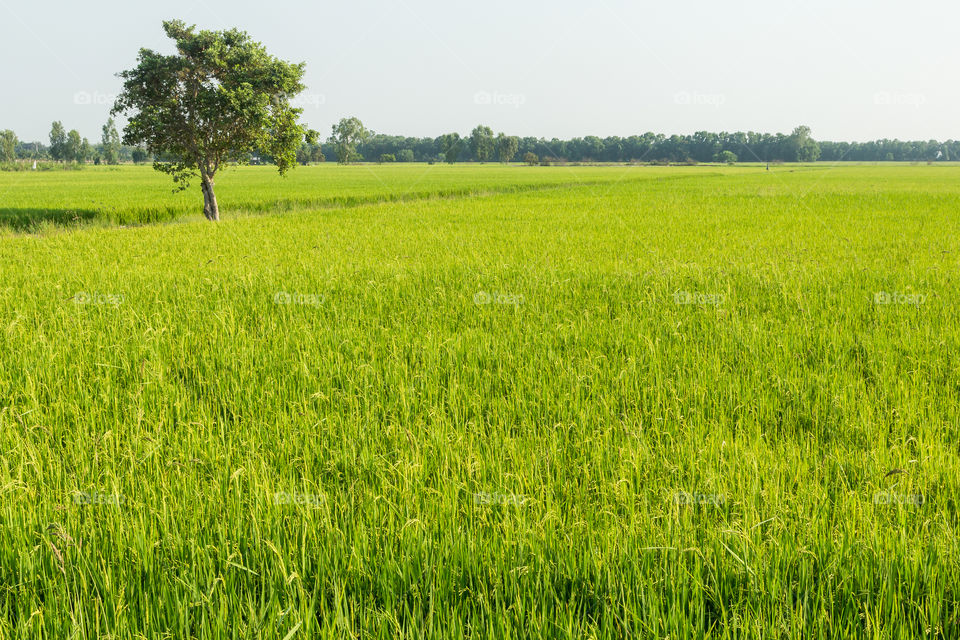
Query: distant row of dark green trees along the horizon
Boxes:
[{"xmin": 0, "ymin": 118, "xmax": 960, "ymax": 164}]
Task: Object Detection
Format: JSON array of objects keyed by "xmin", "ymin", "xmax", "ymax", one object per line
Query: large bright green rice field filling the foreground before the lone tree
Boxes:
[{"xmin": 0, "ymin": 166, "xmax": 960, "ymax": 640}]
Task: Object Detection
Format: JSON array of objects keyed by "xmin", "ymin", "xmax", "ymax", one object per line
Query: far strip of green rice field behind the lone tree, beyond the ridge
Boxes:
[{"xmin": 0, "ymin": 164, "xmax": 666, "ymax": 232}]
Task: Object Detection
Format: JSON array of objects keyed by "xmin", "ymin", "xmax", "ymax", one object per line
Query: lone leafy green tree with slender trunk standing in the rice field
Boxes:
[{"xmin": 112, "ymin": 20, "xmax": 312, "ymax": 220}]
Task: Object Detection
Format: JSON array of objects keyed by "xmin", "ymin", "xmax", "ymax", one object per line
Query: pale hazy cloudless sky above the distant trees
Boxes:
[{"xmin": 0, "ymin": 0, "xmax": 960, "ymax": 141}]
